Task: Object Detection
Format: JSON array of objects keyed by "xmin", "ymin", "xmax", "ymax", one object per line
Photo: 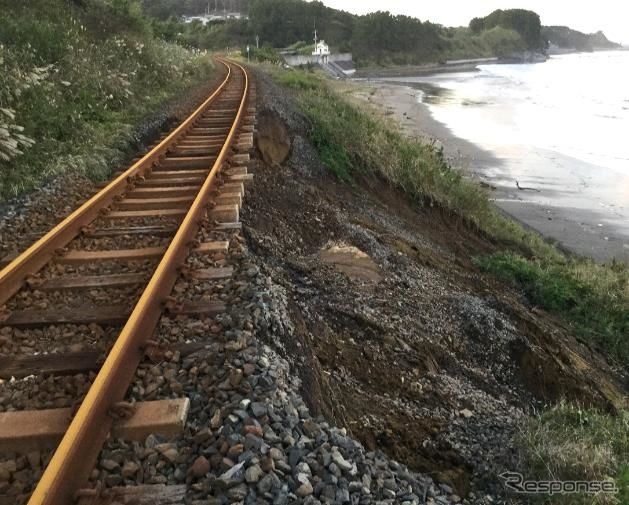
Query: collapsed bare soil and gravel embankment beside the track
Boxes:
[{"xmin": 243, "ymin": 69, "xmax": 626, "ymax": 497}]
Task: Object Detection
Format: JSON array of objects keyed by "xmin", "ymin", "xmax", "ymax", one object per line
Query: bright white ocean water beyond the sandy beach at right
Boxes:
[{"xmin": 388, "ymin": 51, "xmax": 629, "ymax": 236}]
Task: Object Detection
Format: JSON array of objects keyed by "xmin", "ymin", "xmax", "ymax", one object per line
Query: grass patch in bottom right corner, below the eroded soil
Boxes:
[{"xmin": 518, "ymin": 403, "xmax": 629, "ymax": 505}]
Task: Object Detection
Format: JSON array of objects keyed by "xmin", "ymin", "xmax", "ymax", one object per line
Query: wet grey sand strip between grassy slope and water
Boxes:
[{"xmin": 354, "ymin": 82, "xmax": 629, "ymax": 262}]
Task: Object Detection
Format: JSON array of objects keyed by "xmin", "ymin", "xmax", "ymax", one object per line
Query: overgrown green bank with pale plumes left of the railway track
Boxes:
[{"xmin": 0, "ymin": 0, "xmax": 212, "ymax": 200}]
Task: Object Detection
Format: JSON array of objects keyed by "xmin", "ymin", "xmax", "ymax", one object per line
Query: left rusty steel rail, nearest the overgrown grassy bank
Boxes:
[{"xmin": 0, "ymin": 60, "xmax": 231, "ymax": 306}]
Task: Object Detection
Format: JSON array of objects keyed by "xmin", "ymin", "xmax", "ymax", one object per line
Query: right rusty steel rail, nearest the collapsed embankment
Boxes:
[{"xmin": 28, "ymin": 61, "xmax": 249, "ymax": 505}]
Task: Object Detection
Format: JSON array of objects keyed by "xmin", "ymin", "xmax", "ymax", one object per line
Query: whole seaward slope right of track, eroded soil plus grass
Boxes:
[{"xmin": 243, "ymin": 67, "xmax": 629, "ymax": 505}]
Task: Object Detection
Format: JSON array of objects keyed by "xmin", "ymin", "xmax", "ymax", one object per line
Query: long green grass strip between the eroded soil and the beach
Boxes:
[{"xmin": 274, "ymin": 71, "xmax": 629, "ymax": 368}]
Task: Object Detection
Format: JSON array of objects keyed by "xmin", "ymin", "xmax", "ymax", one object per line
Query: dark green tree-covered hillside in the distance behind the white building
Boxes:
[{"xmin": 143, "ymin": 0, "xmax": 620, "ymax": 66}]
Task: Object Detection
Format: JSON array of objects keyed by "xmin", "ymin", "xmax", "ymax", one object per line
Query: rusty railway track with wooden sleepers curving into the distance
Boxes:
[{"xmin": 0, "ymin": 60, "xmax": 255, "ymax": 505}]
